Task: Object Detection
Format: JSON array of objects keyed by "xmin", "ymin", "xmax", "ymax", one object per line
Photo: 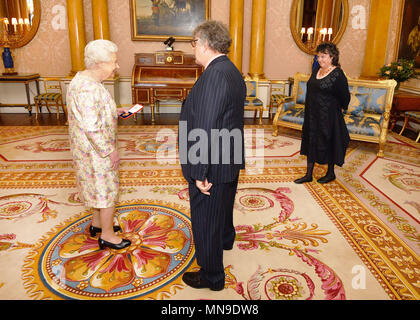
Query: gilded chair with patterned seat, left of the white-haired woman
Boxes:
[{"xmin": 34, "ymin": 78, "xmax": 67, "ymax": 120}]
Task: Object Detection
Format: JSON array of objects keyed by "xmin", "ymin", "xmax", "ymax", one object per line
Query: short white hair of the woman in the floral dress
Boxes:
[{"xmin": 85, "ymin": 39, "xmax": 118, "ymax": 69}]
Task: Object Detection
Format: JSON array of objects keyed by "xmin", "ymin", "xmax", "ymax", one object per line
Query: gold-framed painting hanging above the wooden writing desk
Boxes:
[{"xmin": 130, "ymin": 0, "xmax": 210, "ymax": 41}]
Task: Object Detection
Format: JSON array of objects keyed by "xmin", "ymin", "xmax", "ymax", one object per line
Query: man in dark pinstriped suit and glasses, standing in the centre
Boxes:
[{"xmin": 178, "ymin": 21, "xmax": 246, "ymax": 290}]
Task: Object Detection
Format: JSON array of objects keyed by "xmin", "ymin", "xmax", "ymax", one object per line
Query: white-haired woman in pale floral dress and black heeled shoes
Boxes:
[{"xmin": 67, "ymin": 40, "xmax": 130, "ymax": 249}]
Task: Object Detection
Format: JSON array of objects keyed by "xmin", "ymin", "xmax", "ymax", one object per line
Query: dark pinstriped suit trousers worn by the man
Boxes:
[{"xmin": 189, "ymin": 178, "xmax": 238, "ymax": 287}]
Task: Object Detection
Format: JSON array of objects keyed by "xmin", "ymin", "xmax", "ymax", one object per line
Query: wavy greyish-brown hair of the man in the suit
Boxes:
[{"xmin": 193, "ymin": 20, "xmax": 232, "ymax": 54}]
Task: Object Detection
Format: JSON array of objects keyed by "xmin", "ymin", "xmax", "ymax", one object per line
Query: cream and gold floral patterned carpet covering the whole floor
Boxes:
[{"xmin": 0, "ymin": 126, "xmax": 420, "ymax": 300}]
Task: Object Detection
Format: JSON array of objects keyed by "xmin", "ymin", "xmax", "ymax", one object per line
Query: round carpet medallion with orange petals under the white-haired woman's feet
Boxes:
[{"xmin": 23, "ymin": 200, "xmax": 194, "ymax": 299}]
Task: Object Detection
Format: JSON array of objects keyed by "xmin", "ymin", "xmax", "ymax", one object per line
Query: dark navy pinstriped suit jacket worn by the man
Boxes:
[{"xmin": 178, "ymin": 55, "xmax": 246, "ymax": 184}]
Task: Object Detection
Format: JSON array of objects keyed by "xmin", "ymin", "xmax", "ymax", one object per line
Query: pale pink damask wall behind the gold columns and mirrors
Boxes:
[{"xmin": 4, "ymin": 0, "xmax": 416, "ymax": 87}]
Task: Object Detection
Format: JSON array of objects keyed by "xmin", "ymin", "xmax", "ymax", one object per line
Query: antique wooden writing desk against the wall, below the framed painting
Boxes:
[{"xmin": 131, "ymin": 51, "xmax": 203, "ymax": 123}]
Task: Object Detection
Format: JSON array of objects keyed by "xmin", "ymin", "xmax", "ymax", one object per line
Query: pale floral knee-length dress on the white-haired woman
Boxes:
[{"xmin": 67, "ymin": 72, "xmax": 119, "ymax": 208}]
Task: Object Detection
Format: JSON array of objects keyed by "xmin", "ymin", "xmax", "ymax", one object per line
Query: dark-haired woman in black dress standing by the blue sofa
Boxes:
[{"xmin": 295, "ymin": 42, "xmax": 350, "ymax": 183}]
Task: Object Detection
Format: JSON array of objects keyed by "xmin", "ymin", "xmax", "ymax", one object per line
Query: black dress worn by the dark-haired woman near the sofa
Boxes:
[{"xmin": 300, "ymin": 67, "xmax": 350, "ymax": 166}]
